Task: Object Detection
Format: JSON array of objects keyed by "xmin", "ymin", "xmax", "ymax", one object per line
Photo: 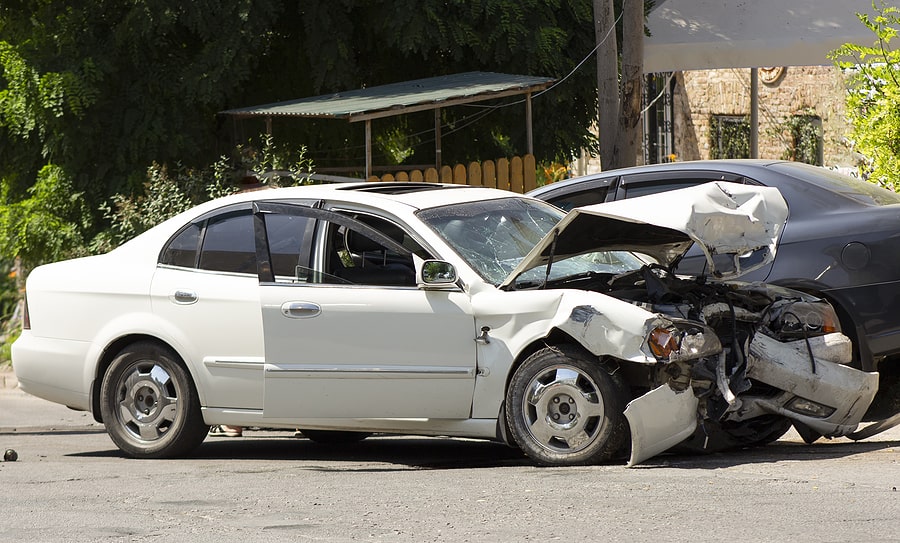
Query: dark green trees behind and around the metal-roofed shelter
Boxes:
[{"xmin": 0, "ymin": 0, "xmax": 612, "ymax": 272}]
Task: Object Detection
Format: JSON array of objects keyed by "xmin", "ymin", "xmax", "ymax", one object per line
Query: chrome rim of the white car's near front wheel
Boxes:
[{"xmin": 522, "ymin": 366, "xmax": 604, "ymax": 453}]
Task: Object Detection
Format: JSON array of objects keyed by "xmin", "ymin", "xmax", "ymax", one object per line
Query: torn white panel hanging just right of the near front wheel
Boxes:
[{"xmin": 625, "ymin": 385, "xmax": 698, "ymax": 467}]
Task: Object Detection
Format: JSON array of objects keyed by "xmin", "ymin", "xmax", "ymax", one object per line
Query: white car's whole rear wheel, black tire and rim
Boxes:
[{"xmin": 100, "ymin": 341, "xmax": 209, "ymax": 458}]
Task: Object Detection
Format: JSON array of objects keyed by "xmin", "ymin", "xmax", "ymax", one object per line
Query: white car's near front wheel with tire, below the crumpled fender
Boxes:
[{"xmin": 506, "ymin": 345, "xmax": 630, "ymax": 466}]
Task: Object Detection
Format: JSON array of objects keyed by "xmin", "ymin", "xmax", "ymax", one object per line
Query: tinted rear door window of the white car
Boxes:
[{"xmin": 198, "ymin": 210, "xmax": 256, "ymax": 273}]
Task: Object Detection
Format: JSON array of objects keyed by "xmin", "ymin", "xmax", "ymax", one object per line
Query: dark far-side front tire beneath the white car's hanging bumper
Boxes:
[{"xmin": 673, "ymin": 415, "xmax": 791, "ymax": 454}]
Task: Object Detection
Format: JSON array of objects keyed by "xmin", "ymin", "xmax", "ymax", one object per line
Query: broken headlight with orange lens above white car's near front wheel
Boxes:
[{"xmin": 644, "ymin": 321, "xmax": 722, "ymax": 363}]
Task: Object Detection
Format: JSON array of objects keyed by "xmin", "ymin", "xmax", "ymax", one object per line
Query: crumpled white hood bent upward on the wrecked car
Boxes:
[{"xmin": 501, "ymin": 182, "xmax": 788, "ymax": 287}]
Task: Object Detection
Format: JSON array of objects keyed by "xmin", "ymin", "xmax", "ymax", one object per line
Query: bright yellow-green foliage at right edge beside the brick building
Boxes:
[{"xmin": 831, "ymin": 2, "xmax": 900, "ymax": 190}]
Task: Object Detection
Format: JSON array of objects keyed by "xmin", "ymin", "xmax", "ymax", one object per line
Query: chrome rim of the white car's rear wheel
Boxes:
[{"xmin": 115, "ymin": 361, "xmax": 178, "ymax": 442}]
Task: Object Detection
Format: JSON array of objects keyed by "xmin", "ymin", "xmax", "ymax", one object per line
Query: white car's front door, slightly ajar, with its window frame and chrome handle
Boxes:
[{"xmin": 257, "ymin": 206, "xmax": 476, "ymax": 420}]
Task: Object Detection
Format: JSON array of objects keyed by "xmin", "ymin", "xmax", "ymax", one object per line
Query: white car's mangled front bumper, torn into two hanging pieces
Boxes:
[{"xmin": 625, "ymin": 333, "xmax": 878, "ymax": 466}]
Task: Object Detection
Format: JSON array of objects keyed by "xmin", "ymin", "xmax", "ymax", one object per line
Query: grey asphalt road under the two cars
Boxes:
[{"xmin": 0, "ymin": 370, "xmax": 900, "ymax": 543}]
